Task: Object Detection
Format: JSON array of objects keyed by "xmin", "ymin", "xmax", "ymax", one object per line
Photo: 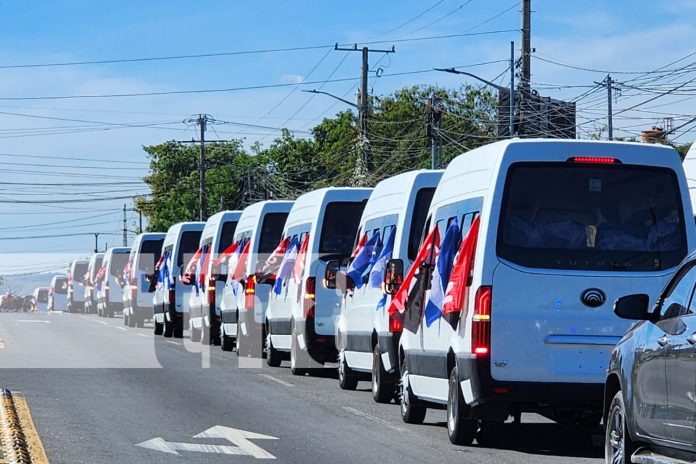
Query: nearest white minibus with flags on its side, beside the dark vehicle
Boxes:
[{"xmin": 390, "ymin": 139, "xmax": 696, "ymax": 446}]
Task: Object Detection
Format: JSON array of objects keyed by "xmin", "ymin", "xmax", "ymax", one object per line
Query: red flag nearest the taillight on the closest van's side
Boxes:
[{"xmin": 442, "ymin": 216, "xmax": 481, "ymax": 327}]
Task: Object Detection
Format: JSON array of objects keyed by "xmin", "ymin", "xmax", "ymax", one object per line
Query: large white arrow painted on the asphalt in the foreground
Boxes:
[{"xmin": 135, "ymin": 425, "xmax": 278, "ymax": 459}]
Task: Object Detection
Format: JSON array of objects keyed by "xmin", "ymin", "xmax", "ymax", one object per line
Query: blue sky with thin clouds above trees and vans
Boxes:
[{"xmin": 0, "ymin": 0, "xmax": 696, "ymax": 274}]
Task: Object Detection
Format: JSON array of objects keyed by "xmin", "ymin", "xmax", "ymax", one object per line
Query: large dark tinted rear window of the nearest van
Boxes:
[{"xmin": 497, "ymin": 162, "xmax": 687, "ymax": 271}]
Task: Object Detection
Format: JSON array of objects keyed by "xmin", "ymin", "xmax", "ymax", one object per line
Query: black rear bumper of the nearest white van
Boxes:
[{"xmin": 457, "ymin": 356, "xmax": 604, "ymax": 412}]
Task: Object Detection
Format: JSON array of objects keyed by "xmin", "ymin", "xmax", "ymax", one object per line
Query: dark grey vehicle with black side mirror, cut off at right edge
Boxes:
[{"xmin": 604, "ymin": 253, "xmax": 696, "ymax": 464}]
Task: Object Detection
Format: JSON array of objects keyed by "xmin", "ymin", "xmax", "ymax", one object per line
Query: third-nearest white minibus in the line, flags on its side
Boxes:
[{"xmin": 266, "ymin": 187, "xmax": 372, "ymax": 375}]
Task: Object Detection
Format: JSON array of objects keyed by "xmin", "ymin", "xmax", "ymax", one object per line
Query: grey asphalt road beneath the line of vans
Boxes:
[{"xmin": 0, "ymin": 313, "xmax": 603, "ymax": 464}]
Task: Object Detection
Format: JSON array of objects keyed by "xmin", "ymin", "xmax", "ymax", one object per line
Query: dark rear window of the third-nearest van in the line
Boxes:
[{"xmin": 319, "ymin": 201, "xmax": 366, "ymax": 256}]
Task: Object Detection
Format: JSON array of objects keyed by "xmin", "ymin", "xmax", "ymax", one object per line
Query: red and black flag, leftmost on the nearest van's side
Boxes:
[{"xmin": 388, "ymin": 227, "xmax": 440, "ymax": 333}]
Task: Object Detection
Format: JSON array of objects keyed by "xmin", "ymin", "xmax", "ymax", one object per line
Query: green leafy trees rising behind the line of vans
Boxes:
[{"xmin": 136, "ymin": 86, "xmax": 497, "ymax": 231}]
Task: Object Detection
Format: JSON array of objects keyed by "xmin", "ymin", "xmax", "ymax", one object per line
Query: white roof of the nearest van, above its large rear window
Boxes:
[{"xmin": 431, "ymin": 138, "xmax": 680, "ymax": 211}]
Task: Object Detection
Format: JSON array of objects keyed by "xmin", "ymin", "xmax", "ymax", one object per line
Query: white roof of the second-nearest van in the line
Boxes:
[{"xmin": 361, "ymin": 169, "xmax": 445, "ymax": 223}]
